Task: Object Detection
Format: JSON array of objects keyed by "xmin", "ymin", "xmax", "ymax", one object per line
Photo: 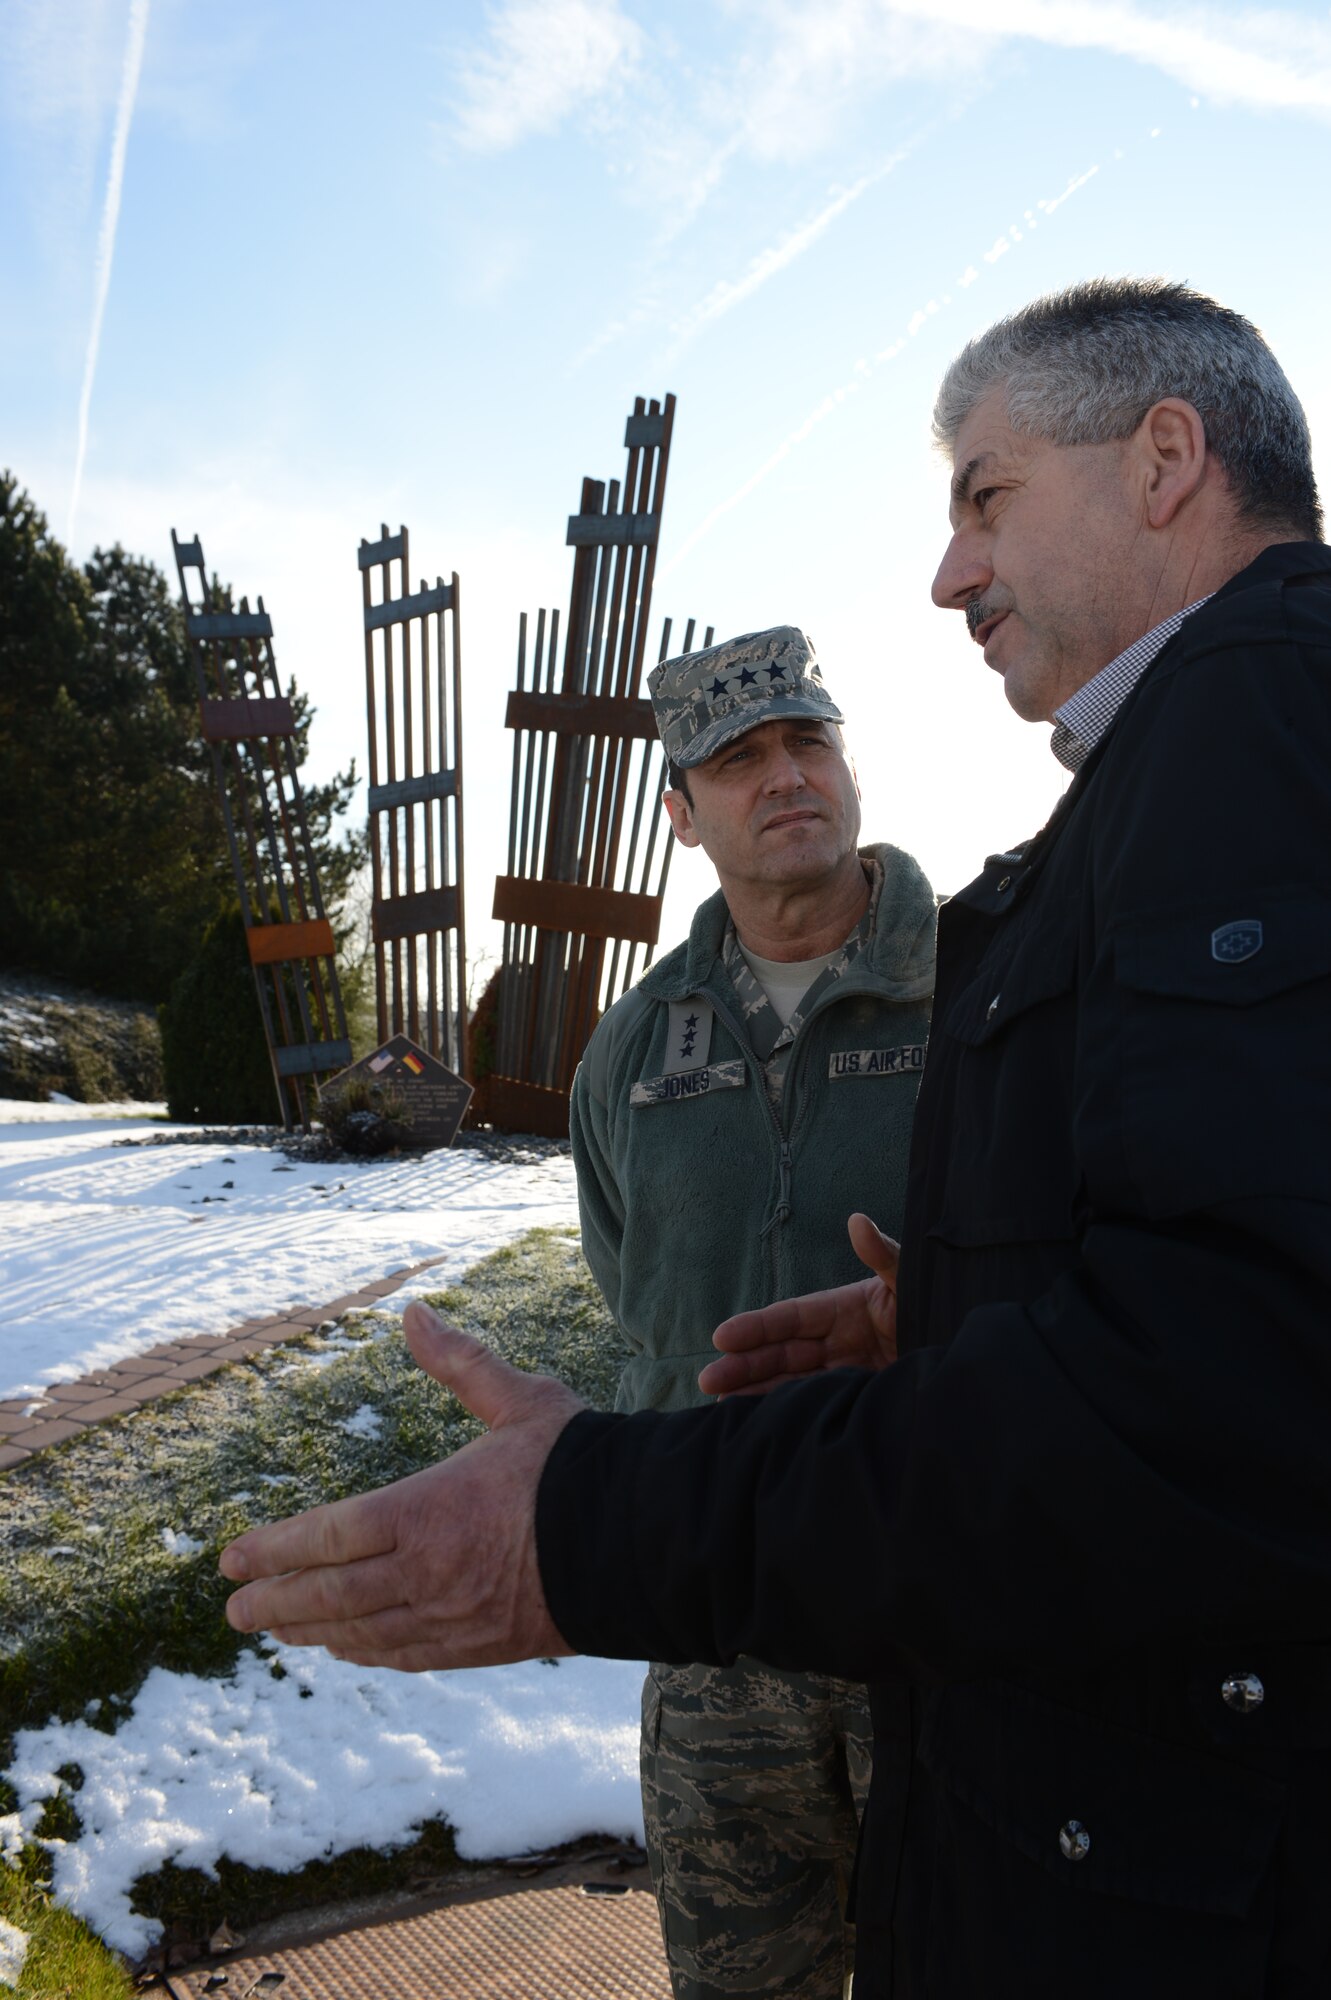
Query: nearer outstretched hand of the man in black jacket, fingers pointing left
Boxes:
[{"xmin": 220, "ymin": 1304, "xmax": 584, "ymax": 1672}]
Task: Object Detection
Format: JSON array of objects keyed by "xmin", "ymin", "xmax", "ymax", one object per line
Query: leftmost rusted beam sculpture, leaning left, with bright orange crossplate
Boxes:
[{"xmin": 172, "ymin": 528, "xmax": 352, "ymax": 1132}]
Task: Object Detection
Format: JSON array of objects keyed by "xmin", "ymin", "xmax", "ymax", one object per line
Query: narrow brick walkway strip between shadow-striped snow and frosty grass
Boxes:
[{"xmin": 0, "ymin": 1256, "xmax": 444, "ymax": 1472}]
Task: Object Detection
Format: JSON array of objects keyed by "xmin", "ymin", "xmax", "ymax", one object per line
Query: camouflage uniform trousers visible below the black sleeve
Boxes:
[{"xmin": 642, "ymin": 1660, "xmax": 873, "ymax": 2000}]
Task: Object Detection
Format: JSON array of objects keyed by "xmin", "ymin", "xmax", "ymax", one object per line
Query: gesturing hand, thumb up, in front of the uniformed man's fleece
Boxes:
[{"xmin": 697, "ymin": 1214, "xmax": 901, "ymax": 1396}]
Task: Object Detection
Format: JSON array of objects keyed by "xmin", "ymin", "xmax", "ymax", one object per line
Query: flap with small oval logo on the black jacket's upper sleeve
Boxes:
[{"xmin": 1113, "ymin": 890, "xmax": 1331, "ymax": 1006}]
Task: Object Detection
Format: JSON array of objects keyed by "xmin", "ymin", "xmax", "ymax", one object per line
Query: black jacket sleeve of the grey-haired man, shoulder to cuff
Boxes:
[{"xmin": 538, "ymin": 592, "xmax": 1331, "ymax": 1678}]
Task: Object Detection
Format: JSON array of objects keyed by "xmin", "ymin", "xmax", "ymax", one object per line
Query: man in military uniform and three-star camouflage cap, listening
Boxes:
[{"xmin": 572, "ymin": 626, "xmax": 933, "ymax": 2000}]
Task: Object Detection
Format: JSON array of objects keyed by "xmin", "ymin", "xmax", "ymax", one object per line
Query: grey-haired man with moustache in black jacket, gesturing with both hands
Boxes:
[{"xmin": 224, "ymin": 282, "xmax": 1331, "ymax": 2000}]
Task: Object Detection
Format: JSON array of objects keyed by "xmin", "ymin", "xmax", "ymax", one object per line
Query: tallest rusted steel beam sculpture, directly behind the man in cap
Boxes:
[{"xmin": 488, "ymin": 396, "xmax": 711, "ymax": 1136}]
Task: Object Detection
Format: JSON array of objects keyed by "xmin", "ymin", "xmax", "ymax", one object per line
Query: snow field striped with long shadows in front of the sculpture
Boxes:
[{"xmin": 0, "ymin": 1104, "xmax": 578, "ymax": 1396}]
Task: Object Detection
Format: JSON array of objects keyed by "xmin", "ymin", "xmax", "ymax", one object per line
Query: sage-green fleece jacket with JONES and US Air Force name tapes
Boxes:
[{"xmin": 570, "ymin": 846, "xmax": 935, "ymax": 1410}]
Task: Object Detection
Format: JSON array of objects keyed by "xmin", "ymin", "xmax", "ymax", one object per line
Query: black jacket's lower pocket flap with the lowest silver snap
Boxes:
[{"xmin": 919, "ymin": 1682, "xmax": 1285, "ymax": 1916}]
